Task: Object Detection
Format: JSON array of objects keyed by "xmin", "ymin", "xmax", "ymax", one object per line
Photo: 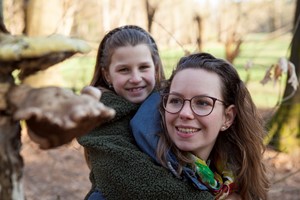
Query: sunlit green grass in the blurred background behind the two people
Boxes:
[{"xmin": 60, "ymin": 34, "xmax": 291, "ymax": 108}]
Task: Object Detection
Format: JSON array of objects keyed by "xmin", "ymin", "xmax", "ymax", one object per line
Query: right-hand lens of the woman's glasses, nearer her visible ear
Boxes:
[{"xmin": 191, "ymin": 96, "xmax": 215, "ymax": 116}]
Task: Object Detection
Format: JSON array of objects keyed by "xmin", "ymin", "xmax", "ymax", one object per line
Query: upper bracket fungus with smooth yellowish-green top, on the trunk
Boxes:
[{"xmin": 0, "ymin": 32, "xmax": 91, "ymax": 80}]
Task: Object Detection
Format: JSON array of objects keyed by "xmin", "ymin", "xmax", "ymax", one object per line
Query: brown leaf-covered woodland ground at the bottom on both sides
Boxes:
[{"xmin": 21, "ymin": 109, "xmax": 300, "ymax": 200}]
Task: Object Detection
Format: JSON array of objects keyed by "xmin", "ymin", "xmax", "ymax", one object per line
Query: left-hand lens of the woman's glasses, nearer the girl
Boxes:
[{"xmin": 163, "ymin": 94, "xmax": 184, "ymax": 113}]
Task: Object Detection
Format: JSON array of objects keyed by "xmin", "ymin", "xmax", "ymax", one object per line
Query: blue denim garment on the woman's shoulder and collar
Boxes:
[{"xmin": 130, "ymin": 92, "xmax": 208, "ymax": 190}]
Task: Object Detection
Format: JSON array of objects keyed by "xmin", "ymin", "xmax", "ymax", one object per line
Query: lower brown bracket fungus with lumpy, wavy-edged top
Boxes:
[{"xmin": 8, "ymin": 85, "xmax": 115, "ymax": 149}]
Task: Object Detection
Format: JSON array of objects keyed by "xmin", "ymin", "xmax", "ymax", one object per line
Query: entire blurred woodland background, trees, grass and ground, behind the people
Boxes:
[{"xmin": 3, "ymin": 0, "xmax": 300, "ymax": 200}]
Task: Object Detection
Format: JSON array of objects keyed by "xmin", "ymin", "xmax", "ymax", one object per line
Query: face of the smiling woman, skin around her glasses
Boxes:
[{"xmin": 165, "ymin": 69, "xmax": 233, "ymax": 160}]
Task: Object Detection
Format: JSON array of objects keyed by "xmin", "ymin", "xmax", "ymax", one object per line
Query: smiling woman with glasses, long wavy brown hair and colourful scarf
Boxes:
[{"xmin": 131, "ymin": 53, "xmax": 269, "ymax": 200}]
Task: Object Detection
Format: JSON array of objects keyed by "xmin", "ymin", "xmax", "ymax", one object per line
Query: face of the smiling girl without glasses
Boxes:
[{"xmin": 105, "ymin": 44, "xmax": 155, "ymax": 103}]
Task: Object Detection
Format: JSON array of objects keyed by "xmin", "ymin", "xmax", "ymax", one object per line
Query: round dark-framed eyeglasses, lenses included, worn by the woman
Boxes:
[{"xmin": 162, "ymin": 94, "xmax": 226, "ymax": 116}]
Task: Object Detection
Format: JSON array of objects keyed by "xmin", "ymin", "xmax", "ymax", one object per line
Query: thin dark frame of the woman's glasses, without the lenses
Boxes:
[{"xmin": 161, "ymin": 93, "xmax": 227, "ymax": 117}]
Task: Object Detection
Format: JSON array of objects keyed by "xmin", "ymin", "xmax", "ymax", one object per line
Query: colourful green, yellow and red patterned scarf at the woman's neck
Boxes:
[{"xmin": 192, "ymin": 155, "xmax": 236, "ymax": 199}]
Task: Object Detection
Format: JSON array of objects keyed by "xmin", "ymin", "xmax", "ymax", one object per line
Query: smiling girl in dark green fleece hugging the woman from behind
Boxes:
[{"xmin": 78, "ymin": 26, "xmax": 213, "ymax": 200}]
